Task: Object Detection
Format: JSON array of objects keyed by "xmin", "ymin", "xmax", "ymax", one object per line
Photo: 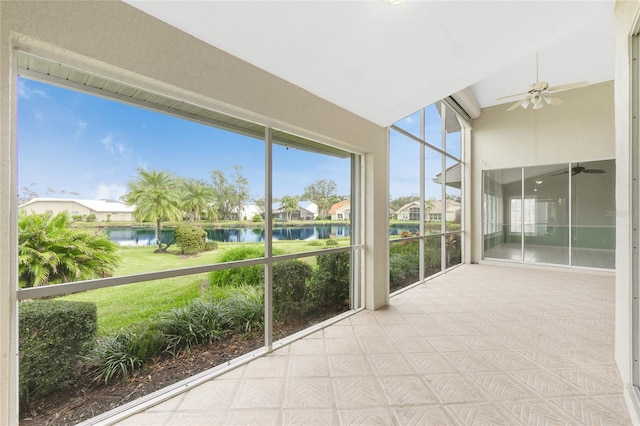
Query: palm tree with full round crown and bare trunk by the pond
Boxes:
[{"xmin": 123, "ymin": 168, "xmax": 182, "ymax": 251}]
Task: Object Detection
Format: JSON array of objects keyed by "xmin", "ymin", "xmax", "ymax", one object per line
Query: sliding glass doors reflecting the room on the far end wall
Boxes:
[{"xmin": 482, "ymin": 160, "xmax": 615, "ymax": 269}]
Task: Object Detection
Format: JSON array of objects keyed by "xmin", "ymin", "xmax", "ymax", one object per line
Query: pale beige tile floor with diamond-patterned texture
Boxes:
[{"xmin": 114, "ymin": 264, "xmax": 631, "ymax": 425}]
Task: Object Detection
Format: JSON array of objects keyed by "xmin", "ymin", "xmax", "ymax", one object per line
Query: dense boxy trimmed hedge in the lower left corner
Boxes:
[{"xmin": 19, "ymin": 300, "xmax": 98, "ymax": 404}]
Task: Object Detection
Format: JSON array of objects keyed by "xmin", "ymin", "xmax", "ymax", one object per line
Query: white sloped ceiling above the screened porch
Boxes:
[{"xmin": 125, "ymin": 0, "xmax": 615, "ymax": 126}]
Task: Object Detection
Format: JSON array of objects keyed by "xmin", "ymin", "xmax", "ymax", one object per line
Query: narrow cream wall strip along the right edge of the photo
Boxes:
[{"xmin": 615, "ymin": 0, "xmax": 640, "ymax": 424}]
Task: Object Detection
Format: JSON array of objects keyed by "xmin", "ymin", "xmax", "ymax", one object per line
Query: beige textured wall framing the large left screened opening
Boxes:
[{"xmin": 0, "ymin": 1, "xmax": 389, "ymax": 424}]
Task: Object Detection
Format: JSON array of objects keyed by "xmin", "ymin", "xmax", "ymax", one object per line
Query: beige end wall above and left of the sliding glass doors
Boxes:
[{"xmin": 470, "ymin": 82, "xmax": 615, "ymax": 262}]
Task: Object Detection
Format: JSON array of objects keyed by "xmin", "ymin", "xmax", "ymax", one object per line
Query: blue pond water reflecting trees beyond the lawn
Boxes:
[{"xmin": 105, "ymin": 224, "xmax": 418, "ymax": 246}]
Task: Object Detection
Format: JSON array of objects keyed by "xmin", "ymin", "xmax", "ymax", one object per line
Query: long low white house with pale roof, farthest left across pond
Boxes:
[{"xmin": 19, "ymin": 198, "xmax": 134, "ymax": 222}]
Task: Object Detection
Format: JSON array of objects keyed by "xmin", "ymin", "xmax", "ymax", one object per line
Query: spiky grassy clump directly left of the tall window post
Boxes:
[{"xmin": 219, "ymin": 285, "xmax": 264, "ymax": 333}]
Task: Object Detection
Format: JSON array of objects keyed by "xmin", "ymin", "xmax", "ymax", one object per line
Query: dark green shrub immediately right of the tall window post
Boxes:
[{"xmin": 273, "ymin": 260, "xmax": 313, "ymax": 319}]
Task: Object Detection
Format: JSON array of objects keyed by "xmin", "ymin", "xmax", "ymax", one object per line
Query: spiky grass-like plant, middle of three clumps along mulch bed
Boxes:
[{"xmin": 156, "ymin": 299, "xmax": 223, "ymax": 355}]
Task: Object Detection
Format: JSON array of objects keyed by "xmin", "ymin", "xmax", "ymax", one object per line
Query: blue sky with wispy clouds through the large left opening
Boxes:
[{"xmin": 17, "ymin": 78, "xmax": 350, "ymax": 203}]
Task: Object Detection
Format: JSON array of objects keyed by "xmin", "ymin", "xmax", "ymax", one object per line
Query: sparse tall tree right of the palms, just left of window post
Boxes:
[{"xmin": 211, "ymin": 165, "xmax": 251, "ymax": 220}]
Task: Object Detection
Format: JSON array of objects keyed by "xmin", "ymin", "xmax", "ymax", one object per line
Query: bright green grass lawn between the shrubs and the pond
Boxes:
[{"xmin": 62, "ymin": 238, "xmax": 349, "ymax": 335}]
